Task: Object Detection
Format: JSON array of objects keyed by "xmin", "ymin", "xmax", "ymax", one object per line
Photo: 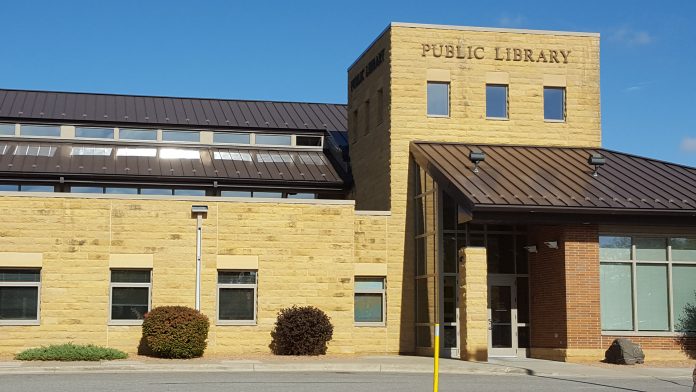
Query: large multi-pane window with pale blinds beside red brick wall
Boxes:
[{"xmin": 599, "ymin": 236, "xmax": 696, "ymax": 333}]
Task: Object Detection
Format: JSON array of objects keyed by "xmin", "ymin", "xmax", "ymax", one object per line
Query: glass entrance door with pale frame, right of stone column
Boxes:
[{"xmin": 488, "ymin": 275, "xmax": 518, "ymax": 357}]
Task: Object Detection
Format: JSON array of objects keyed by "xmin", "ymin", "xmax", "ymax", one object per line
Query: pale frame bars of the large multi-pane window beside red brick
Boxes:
[{"xmin": 598, "ymin": 232, "xmax": 696, "ymax": 337}]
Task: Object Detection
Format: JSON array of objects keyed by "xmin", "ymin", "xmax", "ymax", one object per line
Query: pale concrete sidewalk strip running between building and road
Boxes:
[{"xmin": 0, "ymin": 356, "xmax": 692, "ymax": 378}]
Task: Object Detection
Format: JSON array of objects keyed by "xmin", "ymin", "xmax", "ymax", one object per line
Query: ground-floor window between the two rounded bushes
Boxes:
[{"xmin": 217, "ymin": 271, "xmax": 257, "ymax": 324}]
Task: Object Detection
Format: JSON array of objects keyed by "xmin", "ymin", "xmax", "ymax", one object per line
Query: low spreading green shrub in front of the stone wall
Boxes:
[{"xmin": 15, "ymin": 343, "xmax": 128, "ymax": 361}]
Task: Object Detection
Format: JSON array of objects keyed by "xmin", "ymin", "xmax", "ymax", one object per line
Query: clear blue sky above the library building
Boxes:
[{"xmin": 0, "ymin": 0, "xmax": 696, "ymax": 166}]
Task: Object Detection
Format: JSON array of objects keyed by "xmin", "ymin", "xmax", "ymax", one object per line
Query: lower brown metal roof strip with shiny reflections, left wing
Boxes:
[{"xmin": 0, "ymin": 140, "xmax": 343, "ymax": 188}]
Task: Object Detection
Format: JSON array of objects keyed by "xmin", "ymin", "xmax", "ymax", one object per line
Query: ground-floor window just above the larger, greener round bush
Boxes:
[{"xmin": 109, "ymin": 269, "xmax": 152, "ymax": 324}]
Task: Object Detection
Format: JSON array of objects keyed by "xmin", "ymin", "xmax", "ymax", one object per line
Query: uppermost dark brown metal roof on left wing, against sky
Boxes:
[{"xmin": 0, "ymin": 89, "xmax": 348, "ymax": 131}]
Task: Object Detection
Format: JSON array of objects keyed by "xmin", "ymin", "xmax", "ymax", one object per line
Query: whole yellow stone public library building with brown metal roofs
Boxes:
[{"xmin": 0, "ymin": 23, "xmax": 696, "ymax": 361}]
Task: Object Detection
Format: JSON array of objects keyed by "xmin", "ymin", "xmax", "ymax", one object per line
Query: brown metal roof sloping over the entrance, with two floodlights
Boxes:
[{"xmin": 411, "ymin": 142, "xmax": 696, "ymax": 215}]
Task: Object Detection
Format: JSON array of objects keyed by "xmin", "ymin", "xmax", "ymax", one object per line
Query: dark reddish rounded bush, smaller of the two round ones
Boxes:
[{"xmin": 271, "ymin": 306, "xmax": 333, "ymax": 355}]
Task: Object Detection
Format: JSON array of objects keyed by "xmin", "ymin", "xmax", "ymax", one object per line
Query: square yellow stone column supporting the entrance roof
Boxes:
[{"xmin": 459, "ymin": 247, "xmax": 488, "ymax": 361}]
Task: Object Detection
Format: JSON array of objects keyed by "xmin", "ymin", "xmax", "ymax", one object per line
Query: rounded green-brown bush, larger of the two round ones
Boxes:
[{"xmin": 143, "ymin": 306, "xmax": 210, "ymax": 358}]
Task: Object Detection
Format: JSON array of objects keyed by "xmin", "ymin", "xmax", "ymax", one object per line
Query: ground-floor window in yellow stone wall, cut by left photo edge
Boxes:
[{"xmin": 0, "ymin": 269, "xmax": 41, "ymax": 324}]
